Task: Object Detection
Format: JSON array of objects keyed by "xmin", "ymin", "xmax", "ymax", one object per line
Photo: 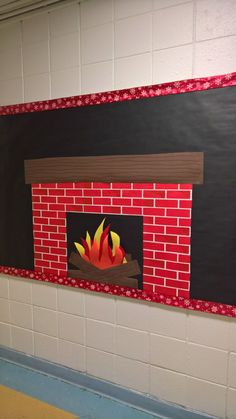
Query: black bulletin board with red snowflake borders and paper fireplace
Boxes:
[{"xmin": 0, "ymin": 73, "xmax": 236, "ymax": 317}]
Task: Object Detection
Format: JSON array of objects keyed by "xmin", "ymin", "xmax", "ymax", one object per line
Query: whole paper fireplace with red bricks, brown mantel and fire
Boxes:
[{"xmin": 25, "ymin": 153, "xmax": 203, "ymax": 297}]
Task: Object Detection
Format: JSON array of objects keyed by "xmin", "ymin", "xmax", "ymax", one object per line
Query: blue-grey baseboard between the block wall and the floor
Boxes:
[{"xmin": 0, "ymin": 345, "xmax": 215, "ymax": 419}]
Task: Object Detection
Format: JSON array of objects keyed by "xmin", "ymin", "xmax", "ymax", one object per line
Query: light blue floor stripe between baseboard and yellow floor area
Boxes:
[{"xmin": 0, "ymin": 360, "xmax": 160, "ymax": 419}]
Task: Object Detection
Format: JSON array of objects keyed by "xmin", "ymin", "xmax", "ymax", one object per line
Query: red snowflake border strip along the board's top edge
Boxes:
[{"xmin": 0, "ymin": 72, "xmax": 236, "ymax": 115}]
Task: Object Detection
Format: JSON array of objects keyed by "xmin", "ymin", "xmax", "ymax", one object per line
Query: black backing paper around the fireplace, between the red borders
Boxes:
[{"xmin": 0, "ymin": 86, "xmax": 236, "ymax": 305}]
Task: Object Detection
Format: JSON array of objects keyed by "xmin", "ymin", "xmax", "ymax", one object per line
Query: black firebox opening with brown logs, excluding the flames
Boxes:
[{"xmin": 66, "ymin": 213, "xmax": 143, "ymax": 289}]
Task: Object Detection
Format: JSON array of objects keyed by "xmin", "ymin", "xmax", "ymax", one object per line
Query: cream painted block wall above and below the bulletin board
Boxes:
[{"xmin": 0, "ymin": 0, "xmax": 236, "ymax": 419}]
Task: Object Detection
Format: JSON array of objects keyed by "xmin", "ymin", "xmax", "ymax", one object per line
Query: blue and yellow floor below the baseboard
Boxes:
[{"xmin": 0, "ymin": 359, "xmax": 160, "ymax": 419}]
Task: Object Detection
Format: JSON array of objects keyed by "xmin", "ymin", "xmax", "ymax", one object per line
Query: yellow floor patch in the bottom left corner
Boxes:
[{"xmin": 0, "ymin": 385, "xmax": 78, "ymax": 419}]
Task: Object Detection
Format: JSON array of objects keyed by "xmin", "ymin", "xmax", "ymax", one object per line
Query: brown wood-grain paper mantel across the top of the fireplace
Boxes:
[{"xmin": 25, "ymin": 152, "xmax": 203, "ymax": 184}]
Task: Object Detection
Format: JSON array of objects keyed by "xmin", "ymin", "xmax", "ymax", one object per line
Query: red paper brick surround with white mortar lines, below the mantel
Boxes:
[{"xmin": 32, "ymin": 182, "xmax": 192, "ymax": 298}]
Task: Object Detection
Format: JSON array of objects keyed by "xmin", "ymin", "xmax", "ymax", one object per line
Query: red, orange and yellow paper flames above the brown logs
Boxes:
[{"xmin": 74, "ymin": 218, "xmax": 127, "ymax": 269}]
